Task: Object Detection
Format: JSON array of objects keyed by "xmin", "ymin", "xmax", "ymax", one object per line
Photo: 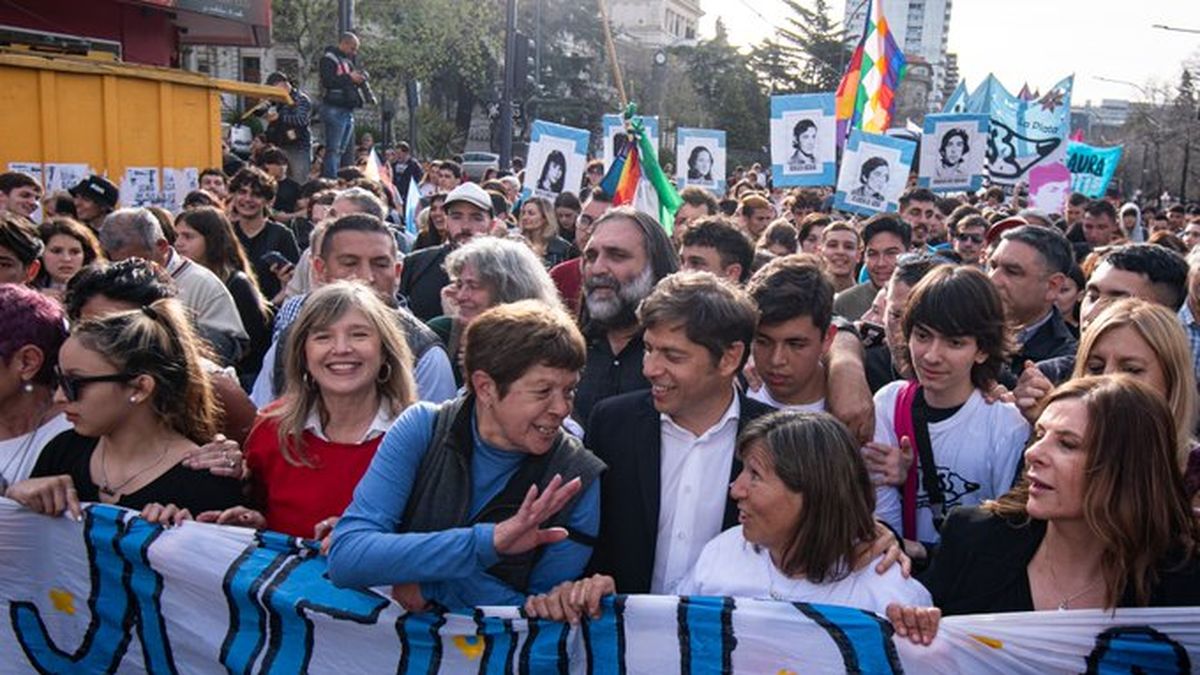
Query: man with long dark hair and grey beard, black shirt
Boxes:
[{"xmin": 572, "ymin": 207, "xmax": 679, "ymax": 425}]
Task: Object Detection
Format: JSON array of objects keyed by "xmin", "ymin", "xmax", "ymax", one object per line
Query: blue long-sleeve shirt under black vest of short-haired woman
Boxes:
[{"xmin": 329, "ymin": 402, "xmax": 600, "ymax": 609}]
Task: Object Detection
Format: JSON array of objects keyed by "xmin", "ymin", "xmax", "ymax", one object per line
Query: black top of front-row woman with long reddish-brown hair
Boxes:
[{"xmin": 916, "ymin": 507, "xmax": 1200, "ymax": 615}]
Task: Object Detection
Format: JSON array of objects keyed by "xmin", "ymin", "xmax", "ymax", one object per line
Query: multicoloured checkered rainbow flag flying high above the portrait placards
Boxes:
[{"xmin": 836, "ymin": 0, "xmax": 905, "ymax": 144}]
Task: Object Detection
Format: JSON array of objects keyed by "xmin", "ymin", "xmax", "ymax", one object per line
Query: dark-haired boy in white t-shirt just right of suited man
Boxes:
[{"xmin": 746, "ymin": 255, "xmax": 900, "ymax": 524}]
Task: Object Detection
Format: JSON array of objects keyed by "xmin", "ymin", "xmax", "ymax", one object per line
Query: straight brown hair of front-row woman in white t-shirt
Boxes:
[{"xmin": 738, "ymin": 412, "xmax": 875, "ymax": 584}]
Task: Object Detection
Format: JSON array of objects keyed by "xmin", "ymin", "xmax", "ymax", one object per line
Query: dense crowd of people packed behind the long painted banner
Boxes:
[{"xmin": 0, "ymin": 86, "xmax": 1200, "ymax": 644}]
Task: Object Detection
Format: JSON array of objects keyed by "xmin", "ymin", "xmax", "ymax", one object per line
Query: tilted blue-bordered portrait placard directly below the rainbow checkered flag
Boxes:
[{"xmin": 833, "ymin": 129, "xmax": 917, "ymax": 215}]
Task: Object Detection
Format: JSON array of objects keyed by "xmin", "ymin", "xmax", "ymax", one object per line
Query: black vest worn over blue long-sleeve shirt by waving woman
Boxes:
[{"xmin": 400, "ymin": 395, "xmax": 605, "ymax": 593}]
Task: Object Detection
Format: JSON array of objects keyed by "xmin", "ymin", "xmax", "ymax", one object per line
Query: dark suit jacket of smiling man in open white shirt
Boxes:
[{"xmin": 583, "ymin": 392, "xmax": 774, "ymax": 593}]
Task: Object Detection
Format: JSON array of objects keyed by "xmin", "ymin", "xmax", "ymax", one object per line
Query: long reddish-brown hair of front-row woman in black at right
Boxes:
[{"xmin": 984, "ymin": 375, "xmax": 1200, "ymax": 608}]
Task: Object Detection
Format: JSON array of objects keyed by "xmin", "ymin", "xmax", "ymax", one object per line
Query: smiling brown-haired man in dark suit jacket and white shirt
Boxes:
[{"xmin": 584, "ymin": 273, "xmax": 770, "ymax": 593}]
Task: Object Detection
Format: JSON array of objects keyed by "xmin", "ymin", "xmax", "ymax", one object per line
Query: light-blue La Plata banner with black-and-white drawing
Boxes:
[{"xmin": 967, "ymin": 76, "xmax": 1075, "ymax": 185}]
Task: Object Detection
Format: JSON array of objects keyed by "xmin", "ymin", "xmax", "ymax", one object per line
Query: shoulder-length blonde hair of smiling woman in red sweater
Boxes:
[{"xmin": 270, "ymin": 281, "xmax": 416, "ymax": 467}]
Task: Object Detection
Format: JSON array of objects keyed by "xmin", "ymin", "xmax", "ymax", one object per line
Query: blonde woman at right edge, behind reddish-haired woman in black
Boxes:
[{"xmin": 1072, "ymin": 298, "xmax": 1196, "ymax": 466}]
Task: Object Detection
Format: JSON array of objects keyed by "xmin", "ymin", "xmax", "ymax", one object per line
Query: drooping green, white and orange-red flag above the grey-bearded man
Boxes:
[{"xmin": 600, "ymin": 103, "xmax": 683, "ymax": 234}]
